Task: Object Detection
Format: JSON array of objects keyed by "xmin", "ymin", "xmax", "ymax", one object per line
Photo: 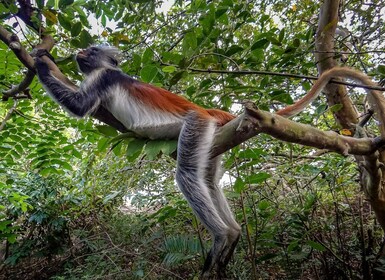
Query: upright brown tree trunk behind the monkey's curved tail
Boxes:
[{"xmin": 315, "ymin": 0, "xmax": 385, "ymax": 279}]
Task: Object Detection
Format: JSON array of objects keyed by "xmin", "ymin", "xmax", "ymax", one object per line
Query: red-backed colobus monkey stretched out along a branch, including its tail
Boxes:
[{"xmin": 35, "ymin": 47, "xmax": 379, "ymax": 278}]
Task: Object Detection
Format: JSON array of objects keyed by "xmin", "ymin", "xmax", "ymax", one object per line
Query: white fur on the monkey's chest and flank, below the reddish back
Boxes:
[{"xmin": 106, "ymin": 86, "xmax": 183, "ymax": 139}]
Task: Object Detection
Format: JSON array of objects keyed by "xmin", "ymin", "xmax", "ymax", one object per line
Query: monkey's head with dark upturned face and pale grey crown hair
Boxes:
[{"xmin": 76, "ymin": 46, "xmax": 119, "ymax": 75}]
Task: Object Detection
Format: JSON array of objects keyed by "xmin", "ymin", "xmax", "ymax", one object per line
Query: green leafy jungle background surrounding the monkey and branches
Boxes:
[{"xmin": 0, "ymin": 0, "xmax": 385, "ymax": 280}]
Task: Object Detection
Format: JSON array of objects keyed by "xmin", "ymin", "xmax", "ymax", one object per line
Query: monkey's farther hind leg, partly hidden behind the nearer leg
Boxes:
[{"xmin": 206, "ymin": 156, "xmax": 241, "ymax": 278}]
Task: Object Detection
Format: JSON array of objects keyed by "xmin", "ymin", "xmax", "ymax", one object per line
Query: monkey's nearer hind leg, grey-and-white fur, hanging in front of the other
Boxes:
[{"xmin": 176, "ymin": 113, "xmax": 230, "ymax": 278}]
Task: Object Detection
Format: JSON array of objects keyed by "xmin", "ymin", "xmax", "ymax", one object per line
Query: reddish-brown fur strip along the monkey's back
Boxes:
[{"xmin": 129, "ymin": 81, "xmax": 235, "ymax": 126}]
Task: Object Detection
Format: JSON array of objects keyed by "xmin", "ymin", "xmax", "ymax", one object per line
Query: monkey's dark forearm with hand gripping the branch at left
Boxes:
[{"xmin": 35, "ymin": 57, "xmax": 100, "ymax": 117}]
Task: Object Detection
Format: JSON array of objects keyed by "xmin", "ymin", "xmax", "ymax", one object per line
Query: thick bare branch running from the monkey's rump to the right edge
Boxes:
[{"xmin": 212, "ymin": 103, "xmax": 385, "ymax": 159}]
